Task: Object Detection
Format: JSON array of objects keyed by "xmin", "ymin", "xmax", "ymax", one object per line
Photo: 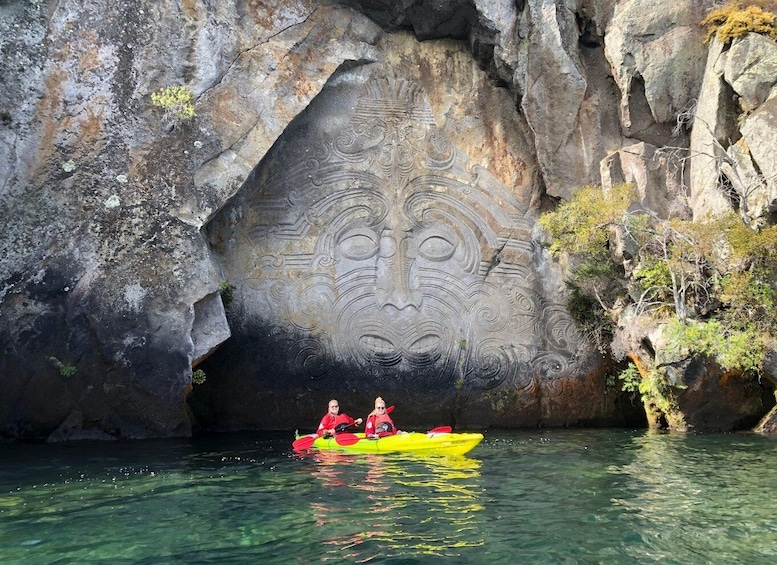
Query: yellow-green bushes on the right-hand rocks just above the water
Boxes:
[{"xmin": 539, "ymin": 184, "xmax": 777, "ymax": 426}]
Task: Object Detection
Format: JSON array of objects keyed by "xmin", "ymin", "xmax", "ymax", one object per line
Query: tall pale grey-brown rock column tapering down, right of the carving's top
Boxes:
[{"xmin": 514, "ymin": 0, "xmax": 622, "ymax": 198}]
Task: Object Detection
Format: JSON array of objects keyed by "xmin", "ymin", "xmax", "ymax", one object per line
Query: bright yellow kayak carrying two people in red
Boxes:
[{"xmin": 296, "ymin": 432, "xmax": 483, "ymax": 455}]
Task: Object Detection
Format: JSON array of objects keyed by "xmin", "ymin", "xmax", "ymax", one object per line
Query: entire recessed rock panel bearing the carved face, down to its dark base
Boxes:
[{"xmin": 194, "ymin": 32, "xmax": 599, "ymax": 428}]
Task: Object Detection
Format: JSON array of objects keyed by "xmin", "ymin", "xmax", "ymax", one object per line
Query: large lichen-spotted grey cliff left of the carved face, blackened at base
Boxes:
[{"xmin": 0, "ymin": 1, "xmax": 388, "ymax": 438}]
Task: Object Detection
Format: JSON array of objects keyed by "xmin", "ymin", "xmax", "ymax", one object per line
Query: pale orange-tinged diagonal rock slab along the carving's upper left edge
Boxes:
[{"xmin": 189, "ymin": 8, "xmax": 380, "ymax": 228}]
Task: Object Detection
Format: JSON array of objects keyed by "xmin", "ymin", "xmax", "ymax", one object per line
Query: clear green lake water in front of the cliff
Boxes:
[{"xmin": 0, "ymin": 430, "xmax": 777, "ymax": 564}]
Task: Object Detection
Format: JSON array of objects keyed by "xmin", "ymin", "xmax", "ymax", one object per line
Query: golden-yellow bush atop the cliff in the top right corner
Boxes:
[{"xmin": 701, "ymin": 0, "xmax": 777, "ymax": 44}]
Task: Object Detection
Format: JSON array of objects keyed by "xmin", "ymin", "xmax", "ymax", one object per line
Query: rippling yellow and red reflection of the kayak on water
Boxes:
[{"xmin": 311, "ymin": 452, "xmax": 484, "ymax": 562}]
